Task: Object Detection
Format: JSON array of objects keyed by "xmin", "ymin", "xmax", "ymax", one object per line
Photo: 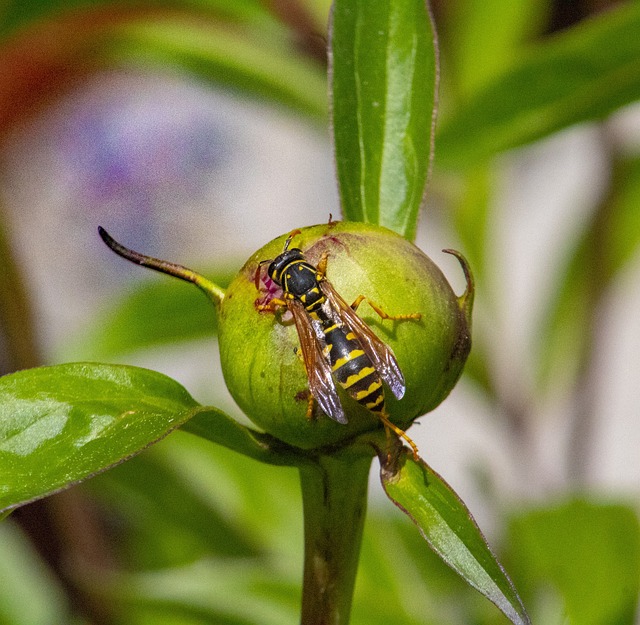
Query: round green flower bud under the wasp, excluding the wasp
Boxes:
[{"xmin": 219, "ymin": 222, "xmax": 473, "ymax": 449}]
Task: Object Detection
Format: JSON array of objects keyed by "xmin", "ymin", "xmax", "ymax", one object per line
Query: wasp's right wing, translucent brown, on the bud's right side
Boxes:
[{"xmin": 320, "ymin": 280, "xmax": 406, "ymax": 399}]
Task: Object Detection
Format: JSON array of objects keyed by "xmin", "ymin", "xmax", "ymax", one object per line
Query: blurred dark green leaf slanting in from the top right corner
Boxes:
[{"xmin": 436, "ymin": 2, "xmax": 640, "ymax": 169}]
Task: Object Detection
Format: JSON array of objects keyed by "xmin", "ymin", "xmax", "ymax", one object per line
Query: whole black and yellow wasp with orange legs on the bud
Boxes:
[{"xmin": 256, "ymin": 230, "xmax": 421, "ymax": 457}]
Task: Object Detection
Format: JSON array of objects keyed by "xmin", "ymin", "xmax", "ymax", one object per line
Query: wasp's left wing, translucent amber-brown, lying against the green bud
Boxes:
[{"xmin": 287, "ymin": 300, "xmax": 347, "ymax": 423}]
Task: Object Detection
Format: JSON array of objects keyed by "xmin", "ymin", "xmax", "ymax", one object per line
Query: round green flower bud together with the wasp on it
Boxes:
[{"xmin": 219, "ymin": 222, "xmax": 473, "ymax": 448}]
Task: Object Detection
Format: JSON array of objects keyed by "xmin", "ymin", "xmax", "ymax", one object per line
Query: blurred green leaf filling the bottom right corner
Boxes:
[{"xmin": 509, "ymin": 499, "xmax": 640, "ymax": 625}]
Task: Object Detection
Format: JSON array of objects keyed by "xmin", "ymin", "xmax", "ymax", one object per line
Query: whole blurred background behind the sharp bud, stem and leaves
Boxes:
[{"xmin": 0, "ymin": 0, "xmax": 640, "ymax": 625}]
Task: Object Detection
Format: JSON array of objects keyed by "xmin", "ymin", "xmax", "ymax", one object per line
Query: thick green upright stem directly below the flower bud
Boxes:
[{"xmin": 300, "ymin": 455, "xmax": 371, "ymax": 625}]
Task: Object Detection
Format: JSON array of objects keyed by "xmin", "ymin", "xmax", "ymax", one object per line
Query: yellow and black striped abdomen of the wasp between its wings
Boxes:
[{"xmin": 323, "ymin": 324, "xmax": 384, "ymax": 412}]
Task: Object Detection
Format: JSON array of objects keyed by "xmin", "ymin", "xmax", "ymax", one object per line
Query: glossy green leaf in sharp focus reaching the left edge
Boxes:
[{"xmin": 0, "ymin": 363, "xmax": 198, "ymax": 510}]
